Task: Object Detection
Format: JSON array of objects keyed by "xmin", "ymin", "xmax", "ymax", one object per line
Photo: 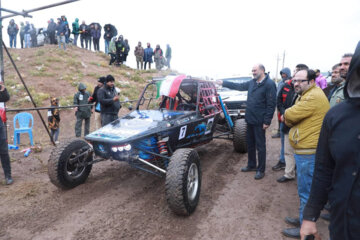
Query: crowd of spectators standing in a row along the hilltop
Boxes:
[{"xmin": 7, "ymin": 15, "xmax": 172, "ymax": 70}]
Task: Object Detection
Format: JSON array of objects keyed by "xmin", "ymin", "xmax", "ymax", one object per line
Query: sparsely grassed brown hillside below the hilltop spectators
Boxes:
[{"xmin": 4, "ymin": 45, "xmax": 174, "ymax": 145}]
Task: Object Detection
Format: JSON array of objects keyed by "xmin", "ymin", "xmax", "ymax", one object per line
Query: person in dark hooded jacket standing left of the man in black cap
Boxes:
[{"xmin": 74, "ymin": 83, "xmax": 91, "ymax": 137}]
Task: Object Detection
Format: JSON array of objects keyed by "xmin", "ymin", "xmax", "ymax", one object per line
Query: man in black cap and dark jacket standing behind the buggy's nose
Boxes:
[{"xmin": 97, "ymin": 75, "xmax": 121, "ymax": 126}]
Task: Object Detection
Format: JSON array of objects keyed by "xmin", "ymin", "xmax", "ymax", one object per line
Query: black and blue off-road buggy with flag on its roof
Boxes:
[{"xmin": 48, "ymin": 75, "xmax": 246, "ymax": 215}]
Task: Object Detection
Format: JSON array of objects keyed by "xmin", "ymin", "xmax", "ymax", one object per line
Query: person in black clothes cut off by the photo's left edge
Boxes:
[{"xmin": 0, "ymin": 82, "xmax": 14, "ymax": 185}]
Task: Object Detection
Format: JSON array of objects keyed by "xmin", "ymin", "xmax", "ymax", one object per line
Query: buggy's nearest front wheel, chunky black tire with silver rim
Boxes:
[{"xmin": 165, "ymin": 148, "xmax": 201, "ymax": 216}]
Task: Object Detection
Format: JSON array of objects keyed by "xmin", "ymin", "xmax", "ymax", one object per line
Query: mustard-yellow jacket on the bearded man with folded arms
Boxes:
[{"xmin": 284, "ymin": 84, "xmax": 330, "ymax": 154}]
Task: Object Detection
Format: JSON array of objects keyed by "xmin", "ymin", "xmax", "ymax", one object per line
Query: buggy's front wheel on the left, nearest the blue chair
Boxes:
[{"xmin": 48, "ymin": 139, "xmax": 93, "ymax": 189}]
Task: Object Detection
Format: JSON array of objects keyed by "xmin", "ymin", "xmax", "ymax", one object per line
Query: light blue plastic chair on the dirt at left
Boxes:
[{"xmin": 14, "ymin": 112, "xmax": 34, "ymax": 146}]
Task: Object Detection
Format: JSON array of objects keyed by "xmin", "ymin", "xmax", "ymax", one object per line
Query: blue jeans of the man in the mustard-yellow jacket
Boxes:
[{"xmin": 294, "ymin": 154, "xmax": 315, "ymax": 223}]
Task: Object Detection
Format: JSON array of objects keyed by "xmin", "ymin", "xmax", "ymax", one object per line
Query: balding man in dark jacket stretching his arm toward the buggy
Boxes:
[{"xmin": 217, "ymin": 64, "xmax": 276, "ymax": 180}]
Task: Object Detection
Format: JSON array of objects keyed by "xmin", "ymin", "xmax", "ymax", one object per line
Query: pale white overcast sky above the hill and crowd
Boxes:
[{"xmin": 1, "ymin": 0, "xmax": 360, "ymax": 78}]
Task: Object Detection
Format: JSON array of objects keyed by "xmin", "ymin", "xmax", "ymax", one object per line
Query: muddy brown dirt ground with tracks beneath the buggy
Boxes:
[{"xmin": 0, "ymin": 114, "xmax": 328, "ymax": 240}]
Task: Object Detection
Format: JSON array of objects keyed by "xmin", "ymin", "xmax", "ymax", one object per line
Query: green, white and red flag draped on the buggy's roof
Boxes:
[{"xmin": 156, "ymin": 75, "xmax": 186, "ymax": 98}]
